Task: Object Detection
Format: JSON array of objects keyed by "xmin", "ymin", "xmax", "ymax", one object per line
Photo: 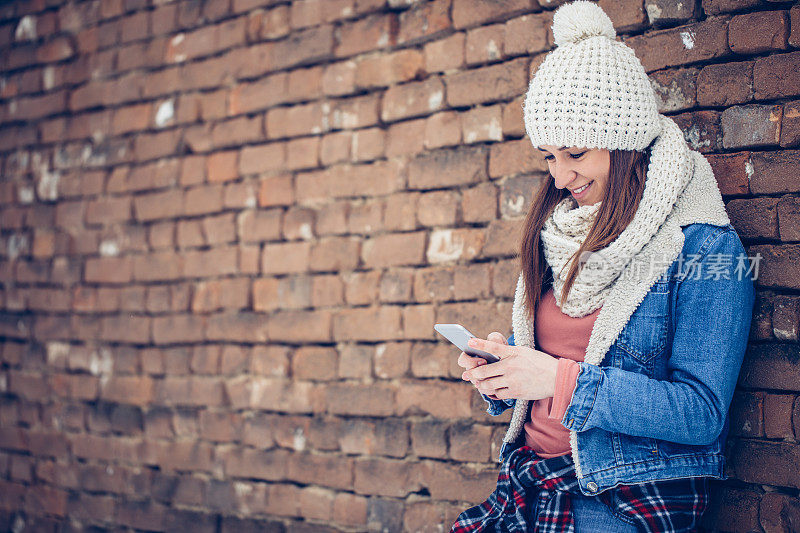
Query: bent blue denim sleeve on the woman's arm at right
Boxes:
[{"xmin": 562, "ymin": 226, "xmax": 755, "ymax": 445}]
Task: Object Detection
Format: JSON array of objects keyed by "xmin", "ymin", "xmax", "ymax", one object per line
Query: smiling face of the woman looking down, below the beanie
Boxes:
[{"xmin": 538, "ymin": 144, "xmax": 611, "ymax": 206}]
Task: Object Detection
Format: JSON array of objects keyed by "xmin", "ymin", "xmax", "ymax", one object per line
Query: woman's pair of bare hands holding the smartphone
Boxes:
[{"xmin": 459, "ymin": 334, "xmax": 558, "ymax": 400}]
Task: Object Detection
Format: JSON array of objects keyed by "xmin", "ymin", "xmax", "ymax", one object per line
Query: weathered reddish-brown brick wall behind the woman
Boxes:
[{"xmin": 0, "ymin": 0, "xmax": 800, "ymax": 532}]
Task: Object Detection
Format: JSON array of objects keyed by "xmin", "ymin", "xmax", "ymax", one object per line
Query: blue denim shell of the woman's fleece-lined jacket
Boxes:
[{"xmin": 482, "ymin": 223, "xmax": 755, "ymax": 496}]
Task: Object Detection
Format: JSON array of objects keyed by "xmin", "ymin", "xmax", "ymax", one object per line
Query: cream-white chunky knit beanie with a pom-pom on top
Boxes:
[{"xmin": 523, "ymin": 0, "xmax": 661, "ymax": 150}]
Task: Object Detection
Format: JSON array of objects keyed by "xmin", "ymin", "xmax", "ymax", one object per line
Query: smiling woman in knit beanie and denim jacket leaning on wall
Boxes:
[{"xmin": 452, "ymin": 1, "xmax": 755, "ymax": 533}]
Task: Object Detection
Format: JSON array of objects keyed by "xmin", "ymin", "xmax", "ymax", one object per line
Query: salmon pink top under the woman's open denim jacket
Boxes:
[{"xmin": 524, "ymin": 287, "xmax": 600, "ymax": 458}]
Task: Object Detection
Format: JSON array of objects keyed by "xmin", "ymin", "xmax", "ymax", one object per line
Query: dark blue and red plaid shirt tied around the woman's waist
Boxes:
[{"xmin": 450, "ymin": 446, "xmax": 708, "ymax": 533}]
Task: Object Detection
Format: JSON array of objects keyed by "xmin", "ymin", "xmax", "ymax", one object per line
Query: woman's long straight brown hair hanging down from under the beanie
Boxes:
[{"xmin": 519, "ymin": 143, "xmax": 653, "ymax": 319}]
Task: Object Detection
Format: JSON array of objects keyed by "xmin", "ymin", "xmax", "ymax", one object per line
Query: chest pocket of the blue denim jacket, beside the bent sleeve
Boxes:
[{"xmin": 616, "ymin": 281, "xmax": 670, "ymax": 366}]
